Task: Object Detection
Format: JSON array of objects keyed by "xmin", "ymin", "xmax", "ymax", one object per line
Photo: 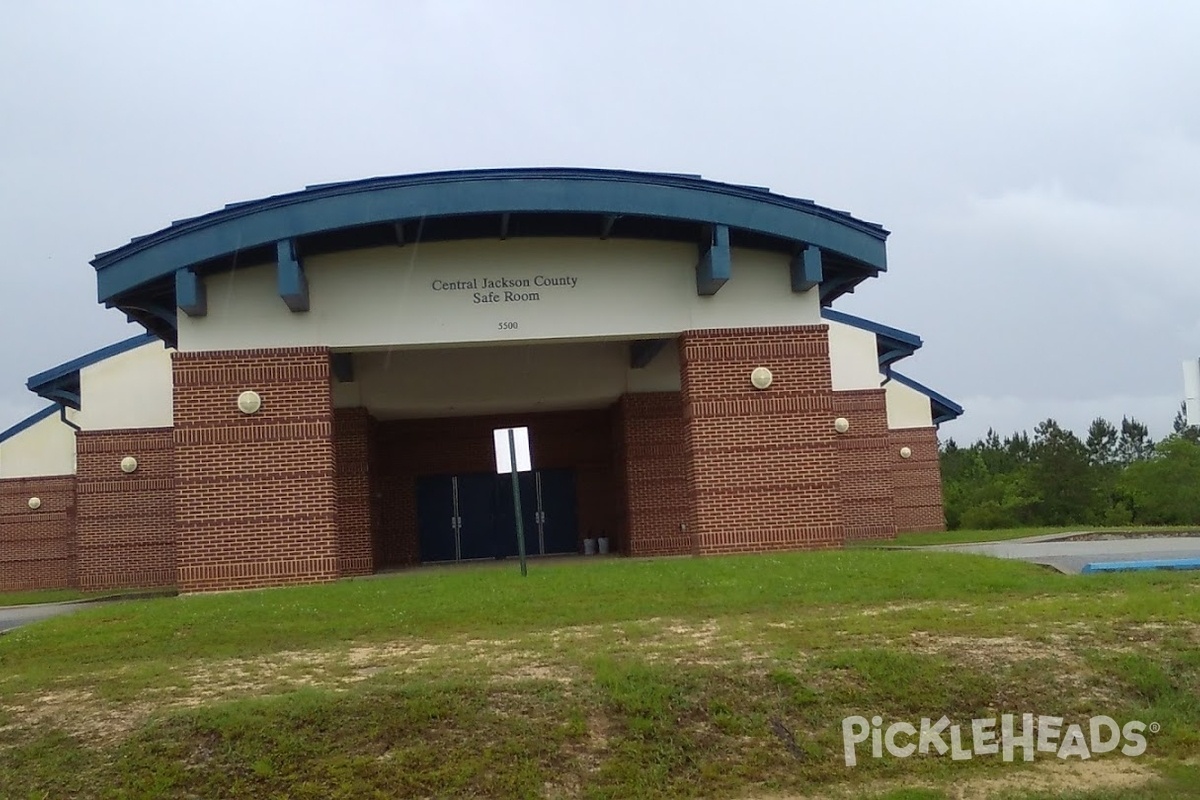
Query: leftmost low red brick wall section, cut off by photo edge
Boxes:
[{"xmin": 0, "ymin": 475, "xmax": 77, "ymax": 591}]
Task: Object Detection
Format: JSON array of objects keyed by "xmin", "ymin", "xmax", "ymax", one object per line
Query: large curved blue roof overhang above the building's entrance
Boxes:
[{"xmin": 92, "ymin": 168, "xmax": 888, "ymax": 343}]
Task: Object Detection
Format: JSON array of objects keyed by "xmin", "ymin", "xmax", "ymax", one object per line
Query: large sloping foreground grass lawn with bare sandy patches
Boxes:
[{"xmin": 0, "ymin": 549, "xmax": 1200, "ymax": 800}]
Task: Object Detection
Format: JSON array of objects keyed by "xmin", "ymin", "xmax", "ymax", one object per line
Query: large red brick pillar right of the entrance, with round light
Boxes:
[{"xmin": 680, "ymin": 325, "xmax": 844, "ymax": 553}]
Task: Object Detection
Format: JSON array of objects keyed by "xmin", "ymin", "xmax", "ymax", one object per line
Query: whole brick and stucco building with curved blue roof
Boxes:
[{"xmin": 0, "ymin": 169, "xmax": 961, "ymax": 591}]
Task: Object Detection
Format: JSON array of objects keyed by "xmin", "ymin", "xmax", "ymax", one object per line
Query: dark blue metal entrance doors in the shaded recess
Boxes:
[{"xmin": 416, "ymin": 470, "xmax": 578, "ymax": 561}]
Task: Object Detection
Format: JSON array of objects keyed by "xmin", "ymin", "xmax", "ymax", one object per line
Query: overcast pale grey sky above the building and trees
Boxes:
[{"xmin": 0, "ymin": 0, "xmax": 1200, "ymax": 441}]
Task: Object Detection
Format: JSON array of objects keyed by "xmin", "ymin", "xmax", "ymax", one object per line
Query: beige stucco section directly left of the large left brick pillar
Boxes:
[{"xmin": 79, "ymin": 342, "xmax": 174, "ymax": 431}]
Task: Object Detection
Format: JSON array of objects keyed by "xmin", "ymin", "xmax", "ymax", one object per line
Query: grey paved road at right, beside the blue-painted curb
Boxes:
[{"xmin": 930, "ymin": 536, "xmax": 1200, "ymax": 573}]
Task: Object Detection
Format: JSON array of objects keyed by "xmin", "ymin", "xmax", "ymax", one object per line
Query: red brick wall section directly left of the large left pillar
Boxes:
[{"xmin": 76, "ymin": 428, "xmax": 175, "ymax": 590}]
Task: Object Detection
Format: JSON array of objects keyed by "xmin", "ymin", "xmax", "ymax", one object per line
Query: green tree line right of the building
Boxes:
[{"xmin": 941, "ymin": 407, "xmax": 1200, "ymax": 530}]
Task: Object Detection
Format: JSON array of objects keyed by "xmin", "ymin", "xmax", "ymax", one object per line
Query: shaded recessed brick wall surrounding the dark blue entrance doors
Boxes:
[{"xmin": 374, "ymin": 409, "xmax": 620, "ymax": 566}]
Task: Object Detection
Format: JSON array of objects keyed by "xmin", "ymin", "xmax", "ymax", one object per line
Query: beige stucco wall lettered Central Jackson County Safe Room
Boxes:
[{"xmin": 179, "ymin": 239, "xmax": 821, "ymax": 350}]
